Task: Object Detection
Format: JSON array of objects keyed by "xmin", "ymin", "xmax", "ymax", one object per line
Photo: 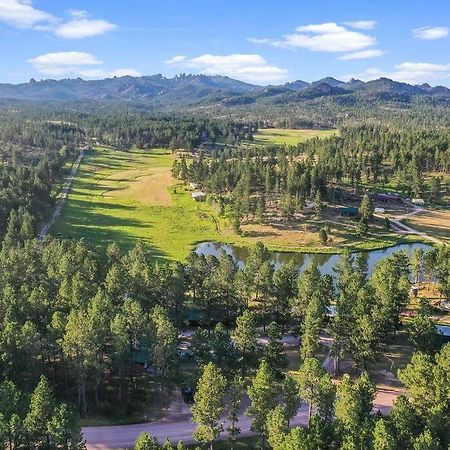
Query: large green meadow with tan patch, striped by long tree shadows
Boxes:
[{"xmin": 51, "ymin": 148, "xmax": 218, "ymax": 260}]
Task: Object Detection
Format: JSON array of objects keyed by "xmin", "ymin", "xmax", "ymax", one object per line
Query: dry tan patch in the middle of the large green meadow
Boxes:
[{"xmin": 104, "ymin": 167, "xmax": 173, "ymax": 206}]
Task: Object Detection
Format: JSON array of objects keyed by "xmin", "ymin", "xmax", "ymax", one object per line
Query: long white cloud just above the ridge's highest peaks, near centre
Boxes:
[{"xmin": 166, "ymin": 54, "xmax": 288, "ymax": 83}]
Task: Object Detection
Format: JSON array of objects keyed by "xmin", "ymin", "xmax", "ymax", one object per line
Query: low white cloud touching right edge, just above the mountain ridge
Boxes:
[{"xmin": 341, "ymin": 62, "xmax": 450, "ymax": 84}]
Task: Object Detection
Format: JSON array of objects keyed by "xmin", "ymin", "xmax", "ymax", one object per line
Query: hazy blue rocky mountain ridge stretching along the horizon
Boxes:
[{"xmin": 0, "ymin": 74, "xmax": 450, "ymax": 107}]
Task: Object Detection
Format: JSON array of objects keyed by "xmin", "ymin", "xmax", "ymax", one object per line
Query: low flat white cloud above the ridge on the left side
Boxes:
[{"xmin": 28, "ymin": 51, "xmax": 140, "ymax": 78}]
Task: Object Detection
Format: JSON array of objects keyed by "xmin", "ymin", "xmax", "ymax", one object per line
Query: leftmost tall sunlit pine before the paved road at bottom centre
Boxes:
[{"xmin": 192, "ymin": 363, "xmax": 227, "ymax": 449}]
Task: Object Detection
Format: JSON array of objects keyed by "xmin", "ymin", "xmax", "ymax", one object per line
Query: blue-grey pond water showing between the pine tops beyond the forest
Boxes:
[{"xmin": 195, "ymin": 242, "xmax": 431, "ymax": 275}]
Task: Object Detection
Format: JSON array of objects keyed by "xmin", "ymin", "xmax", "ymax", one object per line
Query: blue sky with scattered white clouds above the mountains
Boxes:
[{"xmin": 0, "ymin": 0, "xmax": 450, "ymax": 86}]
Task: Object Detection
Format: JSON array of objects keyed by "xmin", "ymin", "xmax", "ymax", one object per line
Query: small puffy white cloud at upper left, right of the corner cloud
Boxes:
[{"xmin": 55, "ymin": 10, "xmax": 117, "ymax": 39}]
